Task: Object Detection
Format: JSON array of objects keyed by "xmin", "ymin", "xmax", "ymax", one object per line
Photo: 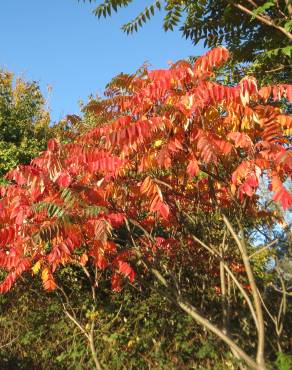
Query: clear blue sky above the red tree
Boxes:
[{"xmin": 0, "ymin": 0, "xmax": 203, "ymax": 121}]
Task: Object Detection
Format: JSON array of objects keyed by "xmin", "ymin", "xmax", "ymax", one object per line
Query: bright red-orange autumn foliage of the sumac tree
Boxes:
[{"xmin": 0, "ymin": 48, "xmax": 292, "ymax": 292}]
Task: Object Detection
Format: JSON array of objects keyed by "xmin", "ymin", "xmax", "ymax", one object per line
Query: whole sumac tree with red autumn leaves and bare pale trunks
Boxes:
[{"xmin": 0, "ymin": 47, "xmax": 292, "ymax": 369}]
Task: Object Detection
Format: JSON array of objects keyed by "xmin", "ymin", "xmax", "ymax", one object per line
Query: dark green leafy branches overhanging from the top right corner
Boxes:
[{"xmin": 81, "ymin": 0, "xmax": 292, "ymax": 82}]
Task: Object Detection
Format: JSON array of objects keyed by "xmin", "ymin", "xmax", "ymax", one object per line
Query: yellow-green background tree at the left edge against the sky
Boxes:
[{"xmin": 0, "ymin": 71, "xmax": 51, "ymax": 177}]
